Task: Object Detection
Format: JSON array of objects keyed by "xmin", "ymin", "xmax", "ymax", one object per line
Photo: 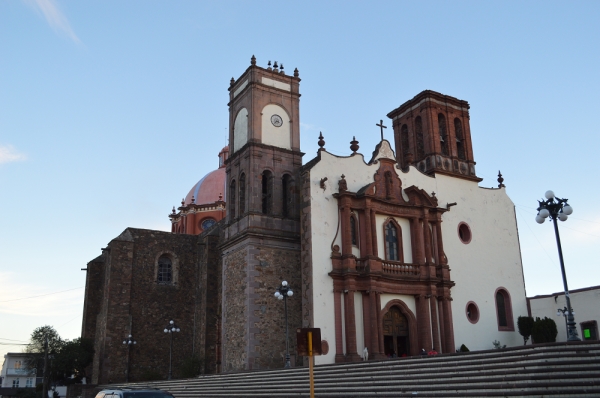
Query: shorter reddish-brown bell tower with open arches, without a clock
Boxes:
[{"xmin": 387, "ymin": 90, "xmax": 481, "ymax": 181}]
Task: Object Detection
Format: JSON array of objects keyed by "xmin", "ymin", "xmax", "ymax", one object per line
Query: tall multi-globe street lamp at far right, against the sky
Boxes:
[{"xmin": 535, "ymin": 191, "xmax": 581, "ymax": 341}]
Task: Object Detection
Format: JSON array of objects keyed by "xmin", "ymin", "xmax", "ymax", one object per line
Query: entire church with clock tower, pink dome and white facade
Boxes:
[{"xmin": 82, "ymin": 57, "xmax": 527, "ymax": 383}]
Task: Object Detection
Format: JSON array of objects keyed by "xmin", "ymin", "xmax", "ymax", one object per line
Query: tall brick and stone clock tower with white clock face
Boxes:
[{"xmin": 221, "ymin": 56, "xmax": 303, "ymax": 371}]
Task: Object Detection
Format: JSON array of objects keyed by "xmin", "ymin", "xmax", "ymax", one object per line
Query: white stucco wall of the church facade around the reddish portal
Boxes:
[{"xmin": 310, "ymin": 143, "xmax": 527, "ymax": 364}]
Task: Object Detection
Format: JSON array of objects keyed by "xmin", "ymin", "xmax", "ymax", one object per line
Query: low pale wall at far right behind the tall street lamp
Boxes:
[{"xmin": 529, "ymin": 286, "xmax": 600, "ymax": 341}]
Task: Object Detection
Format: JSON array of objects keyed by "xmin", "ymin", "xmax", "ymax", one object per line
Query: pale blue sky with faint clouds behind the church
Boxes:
[{"xmin": 0, "ymin": 0, "xmax": 600, "ymax": 355}]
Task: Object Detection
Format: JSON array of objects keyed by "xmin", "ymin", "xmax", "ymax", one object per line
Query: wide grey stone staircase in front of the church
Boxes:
[{"xmin": 101, "ymin": 342, "xmax": 600, "ymax": 398}]
